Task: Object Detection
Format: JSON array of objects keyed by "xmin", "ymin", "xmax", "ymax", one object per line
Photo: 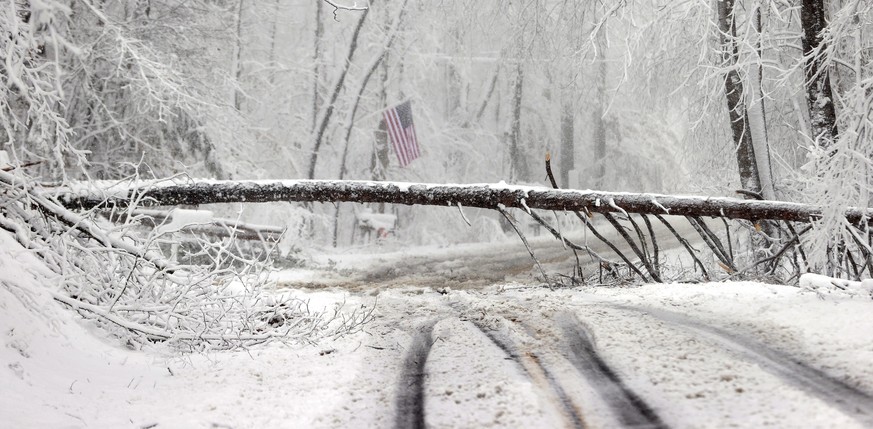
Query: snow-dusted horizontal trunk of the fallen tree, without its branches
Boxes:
[{"xmin": 59, "ymin": 180, "xmax": 873, "ymax": 223}]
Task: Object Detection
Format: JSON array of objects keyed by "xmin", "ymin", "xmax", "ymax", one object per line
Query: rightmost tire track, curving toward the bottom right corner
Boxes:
[{"xmin": 611, "ymin": 305, "xmax": 873, "ymax": 427}]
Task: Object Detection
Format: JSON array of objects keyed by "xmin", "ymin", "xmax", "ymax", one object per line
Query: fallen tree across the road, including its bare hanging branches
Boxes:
[{"xmin": 54, "ymin": 177, "xmax": 873, "ymax": 282}]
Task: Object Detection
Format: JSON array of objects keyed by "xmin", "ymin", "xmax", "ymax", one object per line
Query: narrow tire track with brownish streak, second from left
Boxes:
[{"xmin": 473, "ymin": 322, "xmax": 588, "ymax": 429}]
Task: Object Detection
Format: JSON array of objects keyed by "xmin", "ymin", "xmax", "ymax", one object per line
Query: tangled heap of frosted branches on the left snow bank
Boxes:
[{"xmin": 0, "ymin": 172, "xmax": 370, "ymax": 350}]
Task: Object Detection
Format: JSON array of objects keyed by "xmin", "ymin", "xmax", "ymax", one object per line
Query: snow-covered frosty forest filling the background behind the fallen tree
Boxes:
[{"xmin": 0, "ymin": 0, "xmax": 873, "ymax": 343}]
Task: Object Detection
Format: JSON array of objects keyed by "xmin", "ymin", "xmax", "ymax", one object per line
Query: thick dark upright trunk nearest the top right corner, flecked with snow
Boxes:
[{"xmin": 800, "ymin": 0, "xmax": 837, "ymax": 149}]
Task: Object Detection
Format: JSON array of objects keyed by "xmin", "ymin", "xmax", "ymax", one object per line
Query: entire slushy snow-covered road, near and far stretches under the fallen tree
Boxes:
[{"xmin": 274, "ymin": 217, "xmax": 873, "ymax": 428}]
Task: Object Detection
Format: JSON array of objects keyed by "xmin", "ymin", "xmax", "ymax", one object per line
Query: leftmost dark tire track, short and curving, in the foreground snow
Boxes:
[{"xmin": 394, "ymin": 320, "xmax": 437, "ymax": 429}]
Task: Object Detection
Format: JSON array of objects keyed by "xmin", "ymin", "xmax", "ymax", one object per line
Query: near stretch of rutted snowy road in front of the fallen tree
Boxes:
[{"xmin": 348, "ymin": 283, "xmax": 873, "ymax": 428}]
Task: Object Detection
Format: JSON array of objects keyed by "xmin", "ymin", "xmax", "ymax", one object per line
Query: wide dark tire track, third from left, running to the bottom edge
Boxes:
[{"xmin": 556, "ymin": 314, "xmax": 668, "ymax": 428}]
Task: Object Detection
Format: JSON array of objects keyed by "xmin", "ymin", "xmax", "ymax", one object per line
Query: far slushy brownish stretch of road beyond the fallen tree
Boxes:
[{"xmin": 293, "ymin": 217, "xmax": 708, "ymax": 291}]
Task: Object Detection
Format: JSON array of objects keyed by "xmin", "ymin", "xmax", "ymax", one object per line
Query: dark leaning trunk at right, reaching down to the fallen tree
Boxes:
[{"xmin": 717, "ymin": 0, "xmax": 761, "ymax": 193}]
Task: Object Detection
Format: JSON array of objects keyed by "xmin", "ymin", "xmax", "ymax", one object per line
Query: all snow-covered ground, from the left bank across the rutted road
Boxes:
[{"xmin": 0, "ymin": 231, "xmax": 873, "ymax": 428}]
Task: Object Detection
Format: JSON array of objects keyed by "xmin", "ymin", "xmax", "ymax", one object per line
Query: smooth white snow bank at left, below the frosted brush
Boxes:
[{"xmin": 0, "ymin": 231, "xmax": 374, "ymax": 428}]
